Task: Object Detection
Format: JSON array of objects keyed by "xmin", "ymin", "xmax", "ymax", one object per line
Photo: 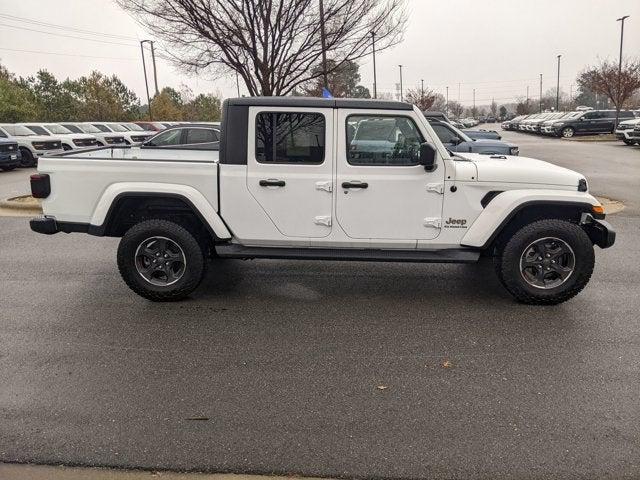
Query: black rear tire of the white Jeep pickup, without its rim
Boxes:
[{"xmin": 118, "ymin": 219, "xmax": 206, "ymax": 302}]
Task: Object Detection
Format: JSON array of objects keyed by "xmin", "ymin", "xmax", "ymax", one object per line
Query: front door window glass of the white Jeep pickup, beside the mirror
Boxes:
[{"xmin": 347, "ymin": 115, "xmax": 424, "ymax": 166}]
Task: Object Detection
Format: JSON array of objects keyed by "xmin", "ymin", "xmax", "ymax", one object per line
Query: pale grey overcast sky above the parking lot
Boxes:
[{"xmin": 0, "ymin": 0, "xmax": 640, "ymax": 105}]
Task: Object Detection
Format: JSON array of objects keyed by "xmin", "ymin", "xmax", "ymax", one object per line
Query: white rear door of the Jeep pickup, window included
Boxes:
[{"xmin": 247, "ymin": 107, "xmax": 333, "ymax": 238}]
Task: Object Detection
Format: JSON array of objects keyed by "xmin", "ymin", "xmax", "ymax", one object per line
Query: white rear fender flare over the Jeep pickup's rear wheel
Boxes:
[{"xmin": 91, "ymin": 182, "xmax": 231, "ymax": 240}]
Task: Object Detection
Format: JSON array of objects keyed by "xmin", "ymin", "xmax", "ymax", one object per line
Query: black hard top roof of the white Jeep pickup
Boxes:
[{"xmin": 225, "ymin": 97, "xmax": 413, "ymax": 110}]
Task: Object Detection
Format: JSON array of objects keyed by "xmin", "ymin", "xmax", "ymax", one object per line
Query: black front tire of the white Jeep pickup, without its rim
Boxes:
[{"xmin": 494, "ymin": 219, "xmax": 595, "ymax": 305}]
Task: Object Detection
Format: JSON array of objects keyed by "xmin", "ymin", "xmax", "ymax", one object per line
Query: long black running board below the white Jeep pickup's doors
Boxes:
[{"xmin": 215, "ymin": 243, "xmax": 480, "ymax": 263}]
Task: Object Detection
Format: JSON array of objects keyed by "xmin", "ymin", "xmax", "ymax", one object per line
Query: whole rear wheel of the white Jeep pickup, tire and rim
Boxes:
[{"xmin": 118, "ymin": 220, "xmax": 205, "ymax": 301}]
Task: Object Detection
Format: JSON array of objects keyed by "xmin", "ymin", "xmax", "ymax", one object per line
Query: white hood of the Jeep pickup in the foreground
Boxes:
[{"xmin": 456, "ymin": 153, "xmax": 584, "ymax": 188}]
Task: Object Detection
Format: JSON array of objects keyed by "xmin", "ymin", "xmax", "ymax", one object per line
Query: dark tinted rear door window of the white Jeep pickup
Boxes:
[{"xmin": 256, "ymin": 112, "xmax": 325, "ymax": 164}]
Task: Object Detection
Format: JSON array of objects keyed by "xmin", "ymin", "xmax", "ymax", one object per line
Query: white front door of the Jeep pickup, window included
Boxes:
[{"xmin": 336, "ymin": 110, "xmax": 444, "ymax": 240}]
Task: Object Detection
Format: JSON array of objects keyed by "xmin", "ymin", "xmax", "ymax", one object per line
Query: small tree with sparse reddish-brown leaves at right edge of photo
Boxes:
[{"xmin": 577, "ymin": 60, "xmax": 640, "ymax": 123}]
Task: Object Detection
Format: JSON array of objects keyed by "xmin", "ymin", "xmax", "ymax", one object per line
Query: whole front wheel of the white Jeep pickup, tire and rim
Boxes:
[{"xmin": 496, "ymin": 219, "xmax": 595, "ymax": 305}]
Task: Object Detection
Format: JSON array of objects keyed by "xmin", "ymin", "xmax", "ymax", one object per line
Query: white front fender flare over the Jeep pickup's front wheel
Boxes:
[{"xmin": 461, "ymin": 189, "xmax": 600, "ymax": 248}]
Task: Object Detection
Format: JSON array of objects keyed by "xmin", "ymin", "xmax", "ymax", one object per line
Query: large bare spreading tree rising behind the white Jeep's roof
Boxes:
[{"xmin": 116, "ymin": 0, "xmax": 407, "ymax": 95}]
